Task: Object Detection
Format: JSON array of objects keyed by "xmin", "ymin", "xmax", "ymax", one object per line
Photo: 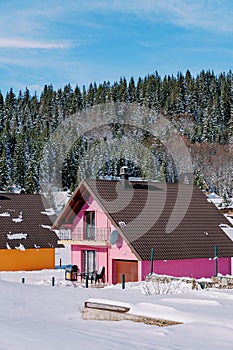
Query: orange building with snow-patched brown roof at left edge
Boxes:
[{"xmin": 0, "ymin": 192, "xmax": 61, "ymax": 271}]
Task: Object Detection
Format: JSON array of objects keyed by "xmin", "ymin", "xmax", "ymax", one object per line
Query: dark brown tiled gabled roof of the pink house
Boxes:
[{"xmin": 54, "ymin": 180, "xmax": 233, "ymax": 260}]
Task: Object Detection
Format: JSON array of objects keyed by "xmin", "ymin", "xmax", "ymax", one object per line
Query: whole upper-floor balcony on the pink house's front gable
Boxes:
[{"xmin": 58, "ymin": 227, "xmax": 111, "ymax": 245}]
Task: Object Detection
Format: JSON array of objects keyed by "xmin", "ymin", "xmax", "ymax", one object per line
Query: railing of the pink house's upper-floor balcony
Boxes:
[{"xmin": 58, "ymin": 227, "xmax": 111, "ymax": 241}]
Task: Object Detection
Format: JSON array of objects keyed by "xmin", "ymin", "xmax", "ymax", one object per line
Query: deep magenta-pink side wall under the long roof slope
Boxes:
[{"xmin": 142, "ymin": 258, "xmax": 231, "ymax": 280}]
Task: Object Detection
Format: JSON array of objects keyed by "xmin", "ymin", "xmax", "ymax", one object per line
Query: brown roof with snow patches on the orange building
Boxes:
[{"xmin": 0, "ymin": 192, "xmax": 60, "ymax": 249}]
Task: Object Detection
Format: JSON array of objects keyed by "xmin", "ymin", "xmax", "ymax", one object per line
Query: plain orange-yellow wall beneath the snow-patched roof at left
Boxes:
[{"xmin": 0, "ymin": 248, "xmax": 55, "ymax": 271}]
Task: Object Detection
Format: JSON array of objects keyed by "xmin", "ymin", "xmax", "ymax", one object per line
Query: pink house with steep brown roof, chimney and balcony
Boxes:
[{"xmin": 53, "ymin": 169, "xmax": 233, "ymax": 283}]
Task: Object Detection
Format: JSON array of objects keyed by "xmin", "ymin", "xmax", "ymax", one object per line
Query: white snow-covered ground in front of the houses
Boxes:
[{"xmin": 0, "ymin": 269, "xmax": 233, "ymax": 350}]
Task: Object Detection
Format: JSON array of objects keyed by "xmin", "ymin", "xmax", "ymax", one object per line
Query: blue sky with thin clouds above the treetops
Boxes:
[{"xmin": 0, "ymin": 0, "xmax": 233, "ymax": 95}]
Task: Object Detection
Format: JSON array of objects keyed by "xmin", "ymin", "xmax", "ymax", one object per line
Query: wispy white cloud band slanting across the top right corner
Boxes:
[{"xmin": 77, "ymin": 0, "xmax": 233, "ymax": 32}]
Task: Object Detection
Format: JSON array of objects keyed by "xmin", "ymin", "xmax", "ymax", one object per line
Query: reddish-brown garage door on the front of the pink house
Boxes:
[{"xmin": 115, "ymin": 260, "xmax": 138, "ymax": 283}]
